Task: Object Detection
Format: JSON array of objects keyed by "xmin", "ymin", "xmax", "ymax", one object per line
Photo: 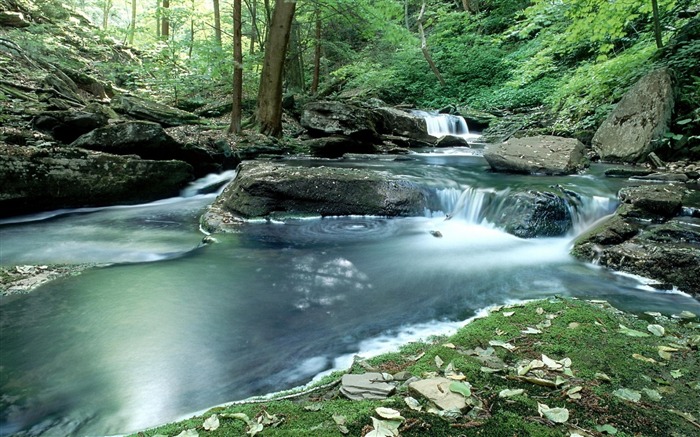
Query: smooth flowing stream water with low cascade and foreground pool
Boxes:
[{"xmin": 0, "ymin": 150, "xmax": 700, "ymax": 436}]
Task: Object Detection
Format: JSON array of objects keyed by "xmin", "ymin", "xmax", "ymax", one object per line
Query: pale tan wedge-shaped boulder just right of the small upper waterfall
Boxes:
[{"xmin": 484, "ymin": 135, "xmax": 586, "ymax": 175}]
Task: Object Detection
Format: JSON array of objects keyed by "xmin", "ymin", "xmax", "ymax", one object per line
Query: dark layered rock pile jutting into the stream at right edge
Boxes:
[{"xmin": 572, "ymin": 185, "xmax": 700, "ymax": 296}]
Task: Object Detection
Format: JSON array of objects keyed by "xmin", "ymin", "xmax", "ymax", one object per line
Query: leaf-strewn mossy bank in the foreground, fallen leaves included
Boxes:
[{"xmin": 134, "ymin": 298, "xmax": 700, "ymax": 437}]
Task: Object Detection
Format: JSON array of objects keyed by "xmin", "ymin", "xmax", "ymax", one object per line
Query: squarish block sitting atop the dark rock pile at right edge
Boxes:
[{"xmin": 618, "ymin": 184, "xmax": 686, "ymax": 217}]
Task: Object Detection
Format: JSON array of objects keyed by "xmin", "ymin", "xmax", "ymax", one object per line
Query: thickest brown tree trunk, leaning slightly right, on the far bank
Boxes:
[{"xmin": 256, "ymin": 0, "xmax": 296, "ymax": 137}]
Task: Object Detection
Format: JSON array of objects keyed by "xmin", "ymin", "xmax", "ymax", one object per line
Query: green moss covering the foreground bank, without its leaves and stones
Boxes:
[{"xmin": 133, "ymin": 298, "xmax": 700, "ymax": 437}]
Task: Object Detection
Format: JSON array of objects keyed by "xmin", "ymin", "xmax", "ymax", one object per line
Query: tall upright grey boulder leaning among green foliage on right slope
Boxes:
[{"xmin": 591, "ymin": 69, "xmax": 673, "ymax": 162}]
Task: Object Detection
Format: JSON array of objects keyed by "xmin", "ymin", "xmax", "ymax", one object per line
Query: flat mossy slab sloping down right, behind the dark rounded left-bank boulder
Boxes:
[{"xmin": 112, "ymin": 96, "xmax": 201, "ymax": 127}]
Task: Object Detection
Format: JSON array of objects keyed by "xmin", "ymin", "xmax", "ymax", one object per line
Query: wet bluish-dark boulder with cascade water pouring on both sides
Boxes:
[{"xmin": 484, "ymin": 191, "xmax": 573, "ymax": 238}]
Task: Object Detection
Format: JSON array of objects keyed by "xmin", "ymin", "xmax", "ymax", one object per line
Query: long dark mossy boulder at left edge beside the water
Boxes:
[{"xmin": 0, "ymin": 143, "xmax": 192, "ymax": 216}]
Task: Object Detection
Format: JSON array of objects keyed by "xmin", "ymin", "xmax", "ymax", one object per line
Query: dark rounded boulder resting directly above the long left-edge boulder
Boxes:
[{"xmin": 71, "ymin": 121, "xmax": 181, "ymax": 159}]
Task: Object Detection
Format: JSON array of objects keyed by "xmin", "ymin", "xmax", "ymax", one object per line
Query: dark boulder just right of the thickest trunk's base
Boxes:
[{"xmin": 301, "ymin": 101, "xmax": 379, "ymax": 142}]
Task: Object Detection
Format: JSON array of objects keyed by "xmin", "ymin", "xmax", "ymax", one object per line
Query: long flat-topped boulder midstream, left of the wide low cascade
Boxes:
[{"xmin": 202, "ymin": 161, "xmax": 428, "ymax": 223}]
